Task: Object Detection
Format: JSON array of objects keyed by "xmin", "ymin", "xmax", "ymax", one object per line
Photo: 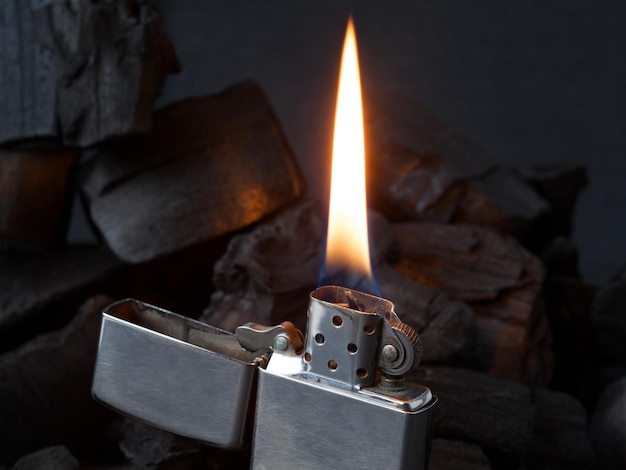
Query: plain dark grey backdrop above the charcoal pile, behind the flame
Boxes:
[{"xmin": 70, "ymin": 0, "xmax": 626, "ymax": 284}]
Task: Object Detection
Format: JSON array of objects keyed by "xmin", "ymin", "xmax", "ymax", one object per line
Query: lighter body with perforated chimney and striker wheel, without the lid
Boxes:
[{"xmin": 252, "ymin": 286, "xmax": 437, "ymax": 470}]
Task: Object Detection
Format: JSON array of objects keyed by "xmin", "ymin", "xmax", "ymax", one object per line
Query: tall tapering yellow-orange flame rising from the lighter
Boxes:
[{"xmin": 324, "ymin": 17, "xmax": 372, "ymax": 290}]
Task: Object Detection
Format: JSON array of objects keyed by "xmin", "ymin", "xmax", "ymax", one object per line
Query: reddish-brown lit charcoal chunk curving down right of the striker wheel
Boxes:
[{"xmin": 394, "ymin": 222, "xmax": 552, "ymax": 383}]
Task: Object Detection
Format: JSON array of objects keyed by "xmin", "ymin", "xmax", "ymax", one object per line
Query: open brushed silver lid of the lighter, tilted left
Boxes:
[{"xmin": 92, "ymin": 300, "xmax": 260, "ymax": 448}]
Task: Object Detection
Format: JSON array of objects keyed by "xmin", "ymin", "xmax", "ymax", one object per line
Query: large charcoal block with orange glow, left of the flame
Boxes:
[{"xmin": 79, "ymin": 82, "xmax": 305, "ymax": 263}]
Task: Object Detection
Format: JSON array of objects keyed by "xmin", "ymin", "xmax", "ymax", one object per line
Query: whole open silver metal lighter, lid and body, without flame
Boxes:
[{"xmin": 92, "ymin": 286, "xmax": 437, "ymax": 470}]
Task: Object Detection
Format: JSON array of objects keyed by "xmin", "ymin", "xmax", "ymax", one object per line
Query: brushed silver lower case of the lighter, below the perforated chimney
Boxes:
[{"xmin": 252, "ymin": 352, "xmax": 436, "ymax": 470}]
